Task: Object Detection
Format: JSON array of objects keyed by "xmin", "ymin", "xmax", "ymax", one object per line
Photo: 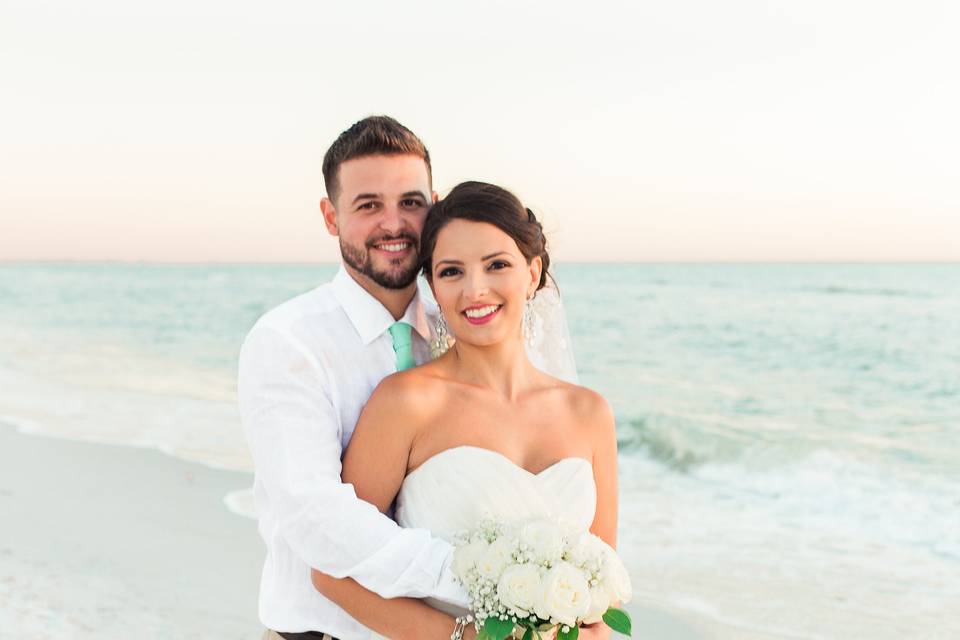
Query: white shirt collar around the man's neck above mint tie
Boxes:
[{"xmin": 333, "ymin": 264, "xmax": 431, "ymax": 345}]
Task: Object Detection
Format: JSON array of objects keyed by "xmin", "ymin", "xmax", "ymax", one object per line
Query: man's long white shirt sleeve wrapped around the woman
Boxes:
[{"xmin": 238, "ymin": 325, "xmax": 467, "ymax": 606}]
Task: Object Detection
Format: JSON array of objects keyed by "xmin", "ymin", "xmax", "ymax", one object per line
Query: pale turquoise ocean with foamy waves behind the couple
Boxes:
[{"xmin": 0, "ymin": 264, "xmax": 960, "ymax": 638}]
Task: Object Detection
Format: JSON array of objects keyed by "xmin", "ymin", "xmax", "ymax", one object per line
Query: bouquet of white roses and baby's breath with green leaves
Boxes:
[{"xmin": 453, "ymin": 520, "xmax": 633, "ymax": 640}]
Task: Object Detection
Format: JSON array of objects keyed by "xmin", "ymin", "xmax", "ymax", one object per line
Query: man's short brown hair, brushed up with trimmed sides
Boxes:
[{"xmin": 323, "ymin": 116, "xmax": 433, "ymax": 202}]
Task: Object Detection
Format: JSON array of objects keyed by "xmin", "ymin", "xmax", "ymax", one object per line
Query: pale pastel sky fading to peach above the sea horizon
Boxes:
[{"xmin": 0, "ymin": 0, "xmax": 960, "ymax": 262}]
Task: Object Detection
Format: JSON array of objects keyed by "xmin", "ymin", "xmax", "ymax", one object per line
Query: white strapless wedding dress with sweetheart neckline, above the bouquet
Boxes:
[{"xmin": 386, "ymin": 446, "xmax": 597, "ymax": 615}]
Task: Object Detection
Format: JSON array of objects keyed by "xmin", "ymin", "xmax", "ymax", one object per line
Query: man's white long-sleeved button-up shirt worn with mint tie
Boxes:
[{"xmin": 238, "ymin": 266, "xmax": 466, "ymax": 640}]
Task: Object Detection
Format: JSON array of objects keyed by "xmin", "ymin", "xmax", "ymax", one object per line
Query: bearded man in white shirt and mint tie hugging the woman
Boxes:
[{"xmin": 239, "ymin": 116, "xmax": 466, "ymax": 640}]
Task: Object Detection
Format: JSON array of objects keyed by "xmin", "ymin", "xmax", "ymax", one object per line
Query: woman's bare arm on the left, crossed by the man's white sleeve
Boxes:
[{"xmin": 311, "ymin": 371, "xmax": 473, "ymax": 638}]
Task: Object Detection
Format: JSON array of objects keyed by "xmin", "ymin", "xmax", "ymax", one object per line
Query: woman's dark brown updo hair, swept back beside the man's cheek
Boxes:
[{"xmin": 420, "ymin": 181, "xmax": 551, "ymax": 291}]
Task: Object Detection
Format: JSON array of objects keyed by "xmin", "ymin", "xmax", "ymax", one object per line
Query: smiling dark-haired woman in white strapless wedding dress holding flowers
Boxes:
[{"xmin": 313, "ymin": 182, "xmax": 617, "ymax": 638}]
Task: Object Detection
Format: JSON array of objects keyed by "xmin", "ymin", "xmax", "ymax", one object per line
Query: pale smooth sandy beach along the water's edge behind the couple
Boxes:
[{"xmin": 0, "ymin": 425, "xmax": 742, "ymax": 640}]
